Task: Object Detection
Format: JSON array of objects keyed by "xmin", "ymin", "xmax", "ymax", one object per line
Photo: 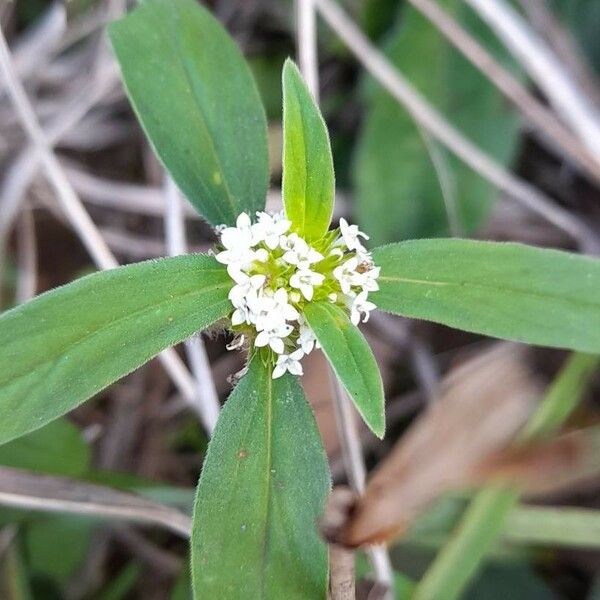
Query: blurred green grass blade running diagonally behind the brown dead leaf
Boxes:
[{"xmin": 413, "ymin": 354, "xmax": 599, "ymax": 600}]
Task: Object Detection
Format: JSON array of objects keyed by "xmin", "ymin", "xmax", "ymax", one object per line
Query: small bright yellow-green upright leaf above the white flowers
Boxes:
[{"xmin": 281, "ymin": 59, "xmax": 335, "ymax": 240}]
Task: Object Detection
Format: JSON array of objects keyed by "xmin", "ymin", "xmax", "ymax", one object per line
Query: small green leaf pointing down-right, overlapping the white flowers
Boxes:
[{"xmin": 304, "ymin": 302, "xmax": 385, "ymax": 438}]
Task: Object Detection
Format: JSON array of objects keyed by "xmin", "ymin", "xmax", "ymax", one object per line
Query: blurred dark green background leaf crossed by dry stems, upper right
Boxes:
[{"xmin": 353, "ymin": 0, "xmax": 519, "ymax": 245}]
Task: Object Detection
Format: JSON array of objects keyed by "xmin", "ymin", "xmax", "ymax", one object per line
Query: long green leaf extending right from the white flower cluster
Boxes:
[{"xmin": 370, "ymin": 239, "xmax": 600, "ymax": 353}]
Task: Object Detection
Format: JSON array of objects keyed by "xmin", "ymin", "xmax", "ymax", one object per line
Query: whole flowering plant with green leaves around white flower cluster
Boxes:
[{"xmin": 0, "ymin": 0, "xmax": 600, "ymax": 600}]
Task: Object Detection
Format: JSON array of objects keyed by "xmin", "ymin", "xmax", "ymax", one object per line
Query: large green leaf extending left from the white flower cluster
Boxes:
[{"xmin": 0, "ymin": 255, "xmax": 231, "ymax": 443}]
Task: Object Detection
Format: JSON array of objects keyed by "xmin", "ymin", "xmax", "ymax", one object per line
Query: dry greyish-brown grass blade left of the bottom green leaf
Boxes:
[{"xmin": 0, "ymin": 467, "xmax": 191, "ymax": 538}]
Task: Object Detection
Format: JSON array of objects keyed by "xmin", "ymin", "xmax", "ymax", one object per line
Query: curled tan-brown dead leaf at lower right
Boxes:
[{"xmin": 322, "ymin": 344, "xmax": 538, "ymax": 547}]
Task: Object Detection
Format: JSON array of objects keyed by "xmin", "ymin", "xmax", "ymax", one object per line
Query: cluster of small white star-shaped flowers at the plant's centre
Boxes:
[{"xmin": 216, "ymin": 212, "xmax": 379, "ymax": 379}]
